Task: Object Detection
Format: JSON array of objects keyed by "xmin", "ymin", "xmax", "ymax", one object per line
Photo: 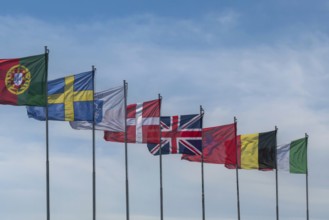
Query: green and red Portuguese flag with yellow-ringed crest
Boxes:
[{"xmin": 0, "ymin": 54, "xmax": 48, "ymax": 106}]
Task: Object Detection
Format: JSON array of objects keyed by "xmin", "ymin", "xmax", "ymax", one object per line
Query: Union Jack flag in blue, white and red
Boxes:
[{"xmin": 147, "ymin": 115, "xmax": 202, "ymax": 155}]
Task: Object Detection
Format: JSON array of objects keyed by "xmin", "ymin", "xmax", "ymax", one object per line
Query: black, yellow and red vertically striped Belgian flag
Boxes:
[{"xmin": 225, "ymin": 130, "xmax": 276, "ymax": 170}]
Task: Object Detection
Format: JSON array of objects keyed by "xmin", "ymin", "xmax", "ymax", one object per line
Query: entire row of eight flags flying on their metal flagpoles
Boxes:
[{"xmin": 0, "ymin": 47, "xmax": 309, "ymax": 220}]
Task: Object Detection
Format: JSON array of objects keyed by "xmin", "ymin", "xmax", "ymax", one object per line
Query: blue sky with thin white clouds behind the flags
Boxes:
[{"xmin": 0, "ymin": 0, "xmax": 329, "ymax": 220}]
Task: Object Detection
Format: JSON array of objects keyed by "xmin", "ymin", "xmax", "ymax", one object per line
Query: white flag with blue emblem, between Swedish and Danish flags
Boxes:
[{"xmin": 70, "ymin": 86, "xmax": 125, "ymax": 131}]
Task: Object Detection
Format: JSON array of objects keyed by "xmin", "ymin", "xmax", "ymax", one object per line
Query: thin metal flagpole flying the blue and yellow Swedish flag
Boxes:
[{"xmin": 92, "ymin": 66, "xmax": 96, "ymax": 220}]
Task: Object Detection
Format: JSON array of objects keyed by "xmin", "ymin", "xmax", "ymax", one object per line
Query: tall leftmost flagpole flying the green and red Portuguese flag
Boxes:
[{"xmin": 45, "ymin": 46, "xmax": 50, "ymax": 220}]
